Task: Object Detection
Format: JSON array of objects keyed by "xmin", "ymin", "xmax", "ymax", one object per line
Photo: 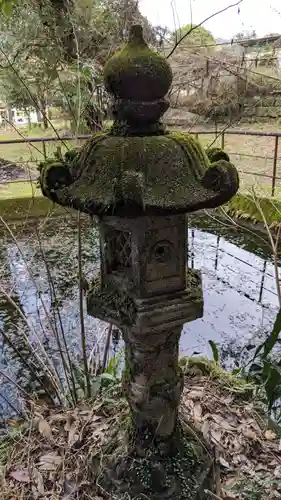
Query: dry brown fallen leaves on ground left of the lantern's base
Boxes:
[{"xmin": 0, "ymin": 394, "xmax": 124, "ymax": 500}]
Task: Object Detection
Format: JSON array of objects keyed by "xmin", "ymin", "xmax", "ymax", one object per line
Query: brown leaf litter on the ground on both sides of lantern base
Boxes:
[{"xmin": 0, "ymin": 374, "xmax": 281, "ymax": 500}]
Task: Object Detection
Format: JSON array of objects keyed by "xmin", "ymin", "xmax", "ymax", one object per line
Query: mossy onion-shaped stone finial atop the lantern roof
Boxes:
[{"xmin": 104, "ymin": 25, "xmax": 172, "ymax": 135}]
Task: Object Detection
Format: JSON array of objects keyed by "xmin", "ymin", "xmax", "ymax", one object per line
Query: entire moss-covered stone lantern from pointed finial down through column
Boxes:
[{"xmin": 40, "ymin": 26, "xmax": 238, "ymax": 498}]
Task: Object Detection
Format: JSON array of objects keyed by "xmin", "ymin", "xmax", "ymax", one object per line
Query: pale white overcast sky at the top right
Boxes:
[{"xmin": 140, "ymin": 0, "xmax": 281, "ymax": 39}]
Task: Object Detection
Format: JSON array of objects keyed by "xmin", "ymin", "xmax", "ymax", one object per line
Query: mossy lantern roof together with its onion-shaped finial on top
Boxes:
[{"xmin": 40, "ymin": 26, "xmax": 239, "ymax": 216}]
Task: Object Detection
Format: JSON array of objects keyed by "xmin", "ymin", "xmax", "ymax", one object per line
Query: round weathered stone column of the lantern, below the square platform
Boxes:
[{"xmin": 123, "ymin": 328, "xmax": 183, "ymax": 454}]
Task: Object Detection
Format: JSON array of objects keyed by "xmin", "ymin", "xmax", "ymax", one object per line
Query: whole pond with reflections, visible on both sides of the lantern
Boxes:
[{"xmin": 0, "ymin": 217, "xmax": 281, "ymax": 413}]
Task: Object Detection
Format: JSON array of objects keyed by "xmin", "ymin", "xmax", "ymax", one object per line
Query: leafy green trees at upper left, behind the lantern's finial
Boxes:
[{"xmin": 0, "ymin": 0, "xmax": 157, "ymax": 128}]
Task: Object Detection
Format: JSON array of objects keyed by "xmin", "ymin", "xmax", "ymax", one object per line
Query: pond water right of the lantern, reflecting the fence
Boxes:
[{"xmin": 181, "ymin": 221, "xmax": 278, "ymax": 366}]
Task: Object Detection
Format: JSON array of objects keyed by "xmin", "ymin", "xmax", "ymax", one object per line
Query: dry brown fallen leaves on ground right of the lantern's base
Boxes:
[{"xmin": 181, "ymin": 376, "xmax": 281, "ymax": 500}]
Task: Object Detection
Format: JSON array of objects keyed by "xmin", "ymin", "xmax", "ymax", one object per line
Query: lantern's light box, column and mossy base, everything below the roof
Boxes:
[{"xmin": 87, "ymin": 215, "xmax": 210, "ymax": 500}]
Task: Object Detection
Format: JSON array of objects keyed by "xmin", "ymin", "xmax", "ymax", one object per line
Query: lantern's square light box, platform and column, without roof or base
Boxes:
[{"xmin": 87, "ymin": 215, "xmax": 203, "ymax": 444}]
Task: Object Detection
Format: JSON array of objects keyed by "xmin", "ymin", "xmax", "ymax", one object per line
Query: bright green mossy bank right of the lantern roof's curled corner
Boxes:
[{"xmin": 224, "ymin": 193, "xmax": 281, "ymax": 228}]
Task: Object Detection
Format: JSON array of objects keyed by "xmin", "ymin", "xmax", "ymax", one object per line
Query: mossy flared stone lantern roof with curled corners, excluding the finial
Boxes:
[{"xmin": 37, "ymin": 119, "xmax": 238, "ymax": 216}]
